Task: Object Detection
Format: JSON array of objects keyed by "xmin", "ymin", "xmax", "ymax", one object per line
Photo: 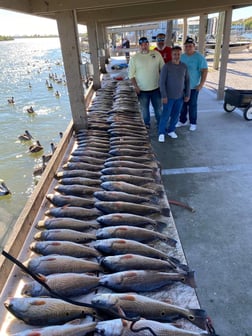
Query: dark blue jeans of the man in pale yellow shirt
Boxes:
[{"xmin": 138, "ymin": 89, "xmax": 162, "ymax": 126}]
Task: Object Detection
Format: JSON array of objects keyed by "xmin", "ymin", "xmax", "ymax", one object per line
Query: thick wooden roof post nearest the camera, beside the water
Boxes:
[{"xmin": 56, "ymin": 11, "xmax": 87, "ymax": 130}]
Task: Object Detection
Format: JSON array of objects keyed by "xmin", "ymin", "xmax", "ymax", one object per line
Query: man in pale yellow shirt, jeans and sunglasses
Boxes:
[{"xmin": 129, "ymin": 37, "xmax": 164, "ymax": 128}]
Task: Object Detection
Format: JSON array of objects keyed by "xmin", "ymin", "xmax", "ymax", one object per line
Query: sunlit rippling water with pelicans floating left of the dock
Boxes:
[{"xmin": 0, "ymin": 38, "xmax": 72, "ymax": 246}]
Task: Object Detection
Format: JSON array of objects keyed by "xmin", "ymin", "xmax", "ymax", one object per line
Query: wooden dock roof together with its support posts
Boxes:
[{"xmin": 0, "ymin": 0, "xmax": 251, "ymax": 130}]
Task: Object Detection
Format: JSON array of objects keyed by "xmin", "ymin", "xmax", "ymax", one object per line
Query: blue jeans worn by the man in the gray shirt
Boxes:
[{"xmin": 158, "ymin": 98, "xmax": 183, "ymax": 134}]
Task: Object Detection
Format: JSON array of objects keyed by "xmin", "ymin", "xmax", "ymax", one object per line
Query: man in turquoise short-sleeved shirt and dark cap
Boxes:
[{"xmin": 176, "ymin": 37, "xmax": 208, "ymax": 131}]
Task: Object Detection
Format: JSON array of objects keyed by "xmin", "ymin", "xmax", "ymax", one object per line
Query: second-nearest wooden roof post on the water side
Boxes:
[{"xmin": 87, "ymin": 20, "xmax": 101, "ymax": 90}]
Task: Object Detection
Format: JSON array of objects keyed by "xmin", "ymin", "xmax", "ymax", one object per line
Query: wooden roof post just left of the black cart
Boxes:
[{"xmin": 217, "ymin": 7, "xmax": 232, "ymax": 100}]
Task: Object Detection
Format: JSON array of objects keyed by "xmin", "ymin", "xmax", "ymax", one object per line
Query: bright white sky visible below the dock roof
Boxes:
[{"xmin": 0, "ymin": 6, "xmax": 252, "ymax": 36}]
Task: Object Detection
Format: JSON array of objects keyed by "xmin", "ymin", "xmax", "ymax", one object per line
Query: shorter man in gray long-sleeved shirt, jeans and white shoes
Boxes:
[{"xmin": 158, "ymin": 46, "xmax": 190, "ymax": 142}]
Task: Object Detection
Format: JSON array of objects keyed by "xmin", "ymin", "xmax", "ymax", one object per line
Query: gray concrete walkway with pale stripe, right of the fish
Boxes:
[{"xmin": 150, "ymin": 88, "xmax": 252, "ymax": 336}]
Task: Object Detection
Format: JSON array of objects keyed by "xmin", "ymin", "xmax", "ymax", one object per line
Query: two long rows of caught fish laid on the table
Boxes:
[{"xmin": 5, "ymin": 80, "xmax": 213, "ymax": 336}]
